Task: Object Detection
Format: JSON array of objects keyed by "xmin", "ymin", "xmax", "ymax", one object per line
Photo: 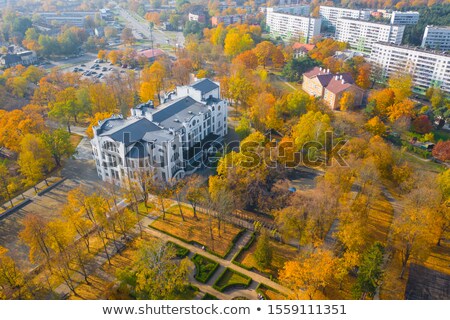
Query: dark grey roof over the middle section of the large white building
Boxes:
[{"xmin": 153, "ymin": 96, "xmax": 208, "ymax": 130}]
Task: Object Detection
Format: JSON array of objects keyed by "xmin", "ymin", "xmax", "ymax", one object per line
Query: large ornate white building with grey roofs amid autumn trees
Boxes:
[{"xmin": 91, "ymin": 79, "xmax": 227, "ymax": 185}]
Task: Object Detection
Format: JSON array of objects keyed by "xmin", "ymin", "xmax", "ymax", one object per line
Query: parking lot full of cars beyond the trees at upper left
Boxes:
[{"xmin": 68, "ymin": 59, "xmax": 137, "ymax": 81}]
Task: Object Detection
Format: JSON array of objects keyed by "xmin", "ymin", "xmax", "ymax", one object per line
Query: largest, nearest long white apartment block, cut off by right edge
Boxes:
[{"xmin": 370, "ymin": 43, "xmax": 450, "ymax": 93}]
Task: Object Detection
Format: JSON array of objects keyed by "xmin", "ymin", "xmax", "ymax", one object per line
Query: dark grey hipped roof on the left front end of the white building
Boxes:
[{"xmin": 100, "ymin": 118, "xmax": 161, "ymax": 145}]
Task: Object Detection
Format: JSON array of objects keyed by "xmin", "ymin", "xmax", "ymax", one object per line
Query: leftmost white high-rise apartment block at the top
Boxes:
[{"xmin": 266, "ymin": 8, "xmax": 321, "ymax": 43}]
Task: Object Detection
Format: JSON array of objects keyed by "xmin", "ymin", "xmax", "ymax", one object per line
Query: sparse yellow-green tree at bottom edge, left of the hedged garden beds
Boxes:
[{"xmin": 118, "ymin": 241, "xmax": 192, "ymax": 299}]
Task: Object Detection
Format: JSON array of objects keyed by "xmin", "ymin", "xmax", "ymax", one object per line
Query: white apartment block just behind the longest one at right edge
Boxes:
[{"xmin": 335, "ymin": 18, "xmax": 405, "ymax": 53}]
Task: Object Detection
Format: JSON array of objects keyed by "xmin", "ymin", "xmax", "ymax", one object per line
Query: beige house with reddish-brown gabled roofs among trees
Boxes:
[{"xmin": 302, "ymin": 67, "xmax": 364, "ymax": 110}]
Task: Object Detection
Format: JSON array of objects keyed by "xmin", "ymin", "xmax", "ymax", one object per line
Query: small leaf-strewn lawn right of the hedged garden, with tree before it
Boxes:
[{"xmin": 241, "ymin": 239, "xmax": 299, "ymax": 278}]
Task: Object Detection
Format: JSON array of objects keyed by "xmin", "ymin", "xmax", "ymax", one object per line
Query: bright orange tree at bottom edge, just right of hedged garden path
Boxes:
[{"xmin": 280, "ymin": 249, "xmax": 336, "ymax": 300}]
